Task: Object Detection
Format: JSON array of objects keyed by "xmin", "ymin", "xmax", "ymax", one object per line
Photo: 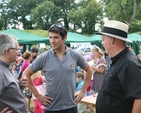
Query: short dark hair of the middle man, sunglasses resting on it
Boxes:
[{"xmin": 48, "ymin": 23, "xmax": 67, "ymax": 39}]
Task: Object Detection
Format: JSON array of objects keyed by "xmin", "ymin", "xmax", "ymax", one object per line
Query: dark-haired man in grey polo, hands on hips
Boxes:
[{"xmin": 23, "ymin": 24, "xmax": 92, "ymax": 113}]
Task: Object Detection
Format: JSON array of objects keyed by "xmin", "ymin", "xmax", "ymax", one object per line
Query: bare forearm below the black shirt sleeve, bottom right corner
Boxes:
[{"xmin": 132, "ymin": 99, "xmax": 141, "ymax": 113}]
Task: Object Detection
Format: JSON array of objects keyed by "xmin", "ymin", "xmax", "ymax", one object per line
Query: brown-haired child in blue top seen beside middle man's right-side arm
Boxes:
[{"xmin": 76, "ymin": 72, "xmax": 87, "ymax": 113}]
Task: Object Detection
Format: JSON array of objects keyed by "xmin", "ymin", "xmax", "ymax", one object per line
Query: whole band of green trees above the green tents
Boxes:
[{"xmin": 0, "ymin": 0, "xmax": 141, "ymax": 35}]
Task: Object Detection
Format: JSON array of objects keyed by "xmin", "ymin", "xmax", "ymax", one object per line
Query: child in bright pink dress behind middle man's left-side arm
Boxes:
[{"xmin": 32, "ymin": 71, "xmax": 45, "ymax": 113}]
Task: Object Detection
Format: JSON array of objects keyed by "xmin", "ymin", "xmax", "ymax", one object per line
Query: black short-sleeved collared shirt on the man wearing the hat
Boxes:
[{"xmin": 96, "ymin": 48, "xmax": 141, "ymax": 113}]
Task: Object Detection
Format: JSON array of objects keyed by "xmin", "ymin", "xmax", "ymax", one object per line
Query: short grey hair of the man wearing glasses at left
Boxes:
[{"xmin": 0, "ymin": 34, "xmax": 17, "ymax": 55}]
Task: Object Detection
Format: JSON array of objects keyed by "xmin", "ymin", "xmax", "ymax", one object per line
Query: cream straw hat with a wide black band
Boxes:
[{"xmin": 96, "ymin": 20, "xmax": 132, "ymax": 42}]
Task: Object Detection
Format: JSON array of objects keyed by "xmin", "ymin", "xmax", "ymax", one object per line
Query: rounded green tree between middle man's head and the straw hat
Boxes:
[{"xmin": 68, "ymin": 0, "xmax": 102, "ymax": 34}]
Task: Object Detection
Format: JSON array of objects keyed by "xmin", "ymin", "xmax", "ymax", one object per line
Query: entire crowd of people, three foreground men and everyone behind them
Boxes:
[{"xmin": 0, "ymin": 20, "xmax": 141, "ymax": 113}]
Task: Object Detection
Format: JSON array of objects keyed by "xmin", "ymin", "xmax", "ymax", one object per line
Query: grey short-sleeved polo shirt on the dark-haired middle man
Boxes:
[{"xmin": 29, "ymin": 48, "xmax": 87, "ymax": 111}]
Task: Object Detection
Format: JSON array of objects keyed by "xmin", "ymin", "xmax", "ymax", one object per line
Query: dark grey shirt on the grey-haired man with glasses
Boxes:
[{"xmin": 0, "ymin": 60, "xmax": 26, "ymax": 113}]
